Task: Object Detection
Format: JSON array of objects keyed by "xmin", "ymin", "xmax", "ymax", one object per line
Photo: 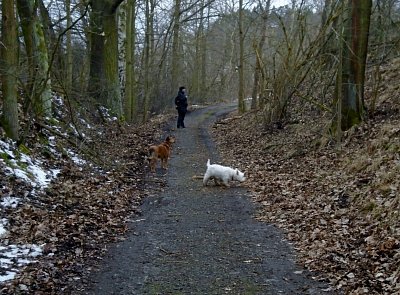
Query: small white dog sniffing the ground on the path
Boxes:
[{"xmin": 203, "ymin": 159, "xmax": 246, "ymax": 187}]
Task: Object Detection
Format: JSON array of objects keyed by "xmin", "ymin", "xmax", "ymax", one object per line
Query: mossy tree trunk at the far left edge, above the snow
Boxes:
[{"xmin": 0, "ymin": 0, "xmax": 19, "ymax": 140}]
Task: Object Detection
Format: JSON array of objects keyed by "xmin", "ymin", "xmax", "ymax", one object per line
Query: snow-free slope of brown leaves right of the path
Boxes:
[{"xmin": 213, "ymin": 59, "xmax": 400, "ymax": 294}]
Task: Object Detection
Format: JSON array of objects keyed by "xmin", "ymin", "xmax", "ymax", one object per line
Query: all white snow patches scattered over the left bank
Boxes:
[{"xmin": 0, "ymin": 95, "xmax": 117, "ymax": 285}]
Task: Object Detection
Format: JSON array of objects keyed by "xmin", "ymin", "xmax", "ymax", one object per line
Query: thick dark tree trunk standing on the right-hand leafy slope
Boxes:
[{"xmin": 336, "ymin": 0, "xmax": 372, "ymax": 130}]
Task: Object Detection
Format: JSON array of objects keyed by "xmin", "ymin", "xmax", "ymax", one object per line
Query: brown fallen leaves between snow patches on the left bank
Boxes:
[{"xmin": 0, "ymin": 112, "xmax": 173, "ymax": 294}]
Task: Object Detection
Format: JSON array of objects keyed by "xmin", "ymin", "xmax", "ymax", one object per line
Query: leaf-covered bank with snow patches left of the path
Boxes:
[{"xmin": 0, "ymin": 105, "xmax": 171, "ymax": 294}]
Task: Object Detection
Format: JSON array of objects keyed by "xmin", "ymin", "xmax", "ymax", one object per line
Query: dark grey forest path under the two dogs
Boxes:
[{"xmin": 83, "ymin": 106, "xmax": 328, "ymax": 295}]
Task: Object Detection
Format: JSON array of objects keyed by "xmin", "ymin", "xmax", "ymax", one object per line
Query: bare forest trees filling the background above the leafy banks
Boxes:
[{"xmin": 1, "ymin": 0, "xmax": 399, "ymax": 141}]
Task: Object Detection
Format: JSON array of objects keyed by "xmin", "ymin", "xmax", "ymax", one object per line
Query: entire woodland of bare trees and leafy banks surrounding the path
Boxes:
[{"xmin": 0, "ymin": 0, "xmax": 400, "ymax": 294}]
